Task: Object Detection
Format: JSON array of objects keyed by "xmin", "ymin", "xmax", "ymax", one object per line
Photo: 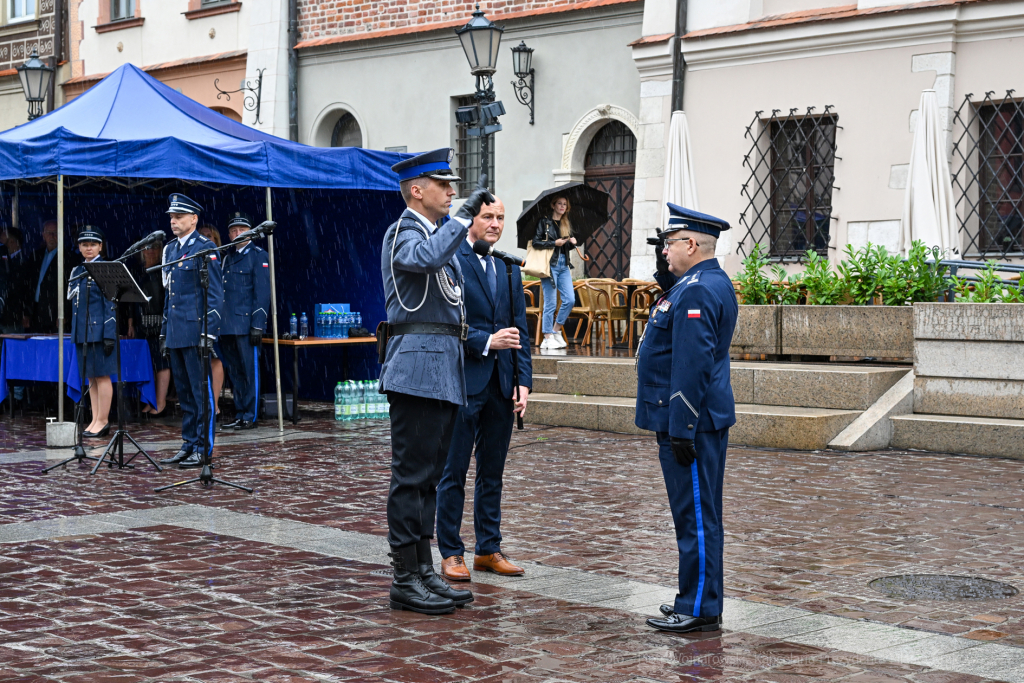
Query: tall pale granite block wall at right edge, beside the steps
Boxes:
[{"xmin": 913, "ymin": 303, "xmax": 1024, "ymax": 419}]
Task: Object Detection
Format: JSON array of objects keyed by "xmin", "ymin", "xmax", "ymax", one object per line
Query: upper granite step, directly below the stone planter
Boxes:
[{"xmin": 534, "ymin": 357, "xmax": 909, "ymax": 411}]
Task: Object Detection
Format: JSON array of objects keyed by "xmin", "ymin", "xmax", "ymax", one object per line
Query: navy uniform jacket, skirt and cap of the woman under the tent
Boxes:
[{"xmin": 68, "ymin": 226, "xmax": 118, "ymax": 378}]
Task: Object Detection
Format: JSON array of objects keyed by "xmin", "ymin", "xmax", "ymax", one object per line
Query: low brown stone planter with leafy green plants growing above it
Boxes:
[{"xmin": 730, "ymin": 306, "xmax": 913, "ymax": 358}]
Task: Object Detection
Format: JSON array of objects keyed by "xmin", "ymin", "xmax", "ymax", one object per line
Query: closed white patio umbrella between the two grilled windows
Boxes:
[{"xmin": 899, "ymin": 90, "xmax": 961, "ymax": 258}]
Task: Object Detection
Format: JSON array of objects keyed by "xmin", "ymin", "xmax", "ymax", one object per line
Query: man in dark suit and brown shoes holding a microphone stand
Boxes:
[{"xmin": 437, "ymin": 198, "xmax": 532, "ymax": 581}]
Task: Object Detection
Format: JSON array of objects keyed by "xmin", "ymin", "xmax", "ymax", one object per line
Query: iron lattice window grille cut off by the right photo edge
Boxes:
[{"xmin": 951, "ymin": 90, "xmax": 1024, "ymax": 258}]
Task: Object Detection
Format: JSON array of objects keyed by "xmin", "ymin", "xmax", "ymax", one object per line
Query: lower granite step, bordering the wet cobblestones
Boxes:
[{"xmin": 526, "ymin": 392, "xmax": 860, "ymax": 451}]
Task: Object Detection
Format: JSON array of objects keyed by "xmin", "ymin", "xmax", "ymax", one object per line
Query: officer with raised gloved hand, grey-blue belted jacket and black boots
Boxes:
[{"xmin": 378, "ymin": 148, "xmax": 494, "ymax": 614}]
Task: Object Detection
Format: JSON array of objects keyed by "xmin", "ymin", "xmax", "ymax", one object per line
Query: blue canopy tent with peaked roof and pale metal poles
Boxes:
[{"xmin": 0, "ymin": 65, "xmax": 404, "ymax": 429}]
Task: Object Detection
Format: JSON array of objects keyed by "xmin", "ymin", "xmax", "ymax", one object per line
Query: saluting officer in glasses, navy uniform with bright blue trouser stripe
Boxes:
[{"xmin": 636, "ymin": 204, "xmax": 738, "ymax": 633}]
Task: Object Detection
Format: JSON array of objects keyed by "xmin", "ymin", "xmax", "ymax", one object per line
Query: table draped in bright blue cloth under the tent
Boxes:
[{"xmin": 0, "ymin": 335, "xmax": 157, "ymax": 410}]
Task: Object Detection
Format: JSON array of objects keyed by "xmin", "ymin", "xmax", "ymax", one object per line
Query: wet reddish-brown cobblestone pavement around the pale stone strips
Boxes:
[{"xmin": 0, "ymin": 411, "xmax": 1024, "ymax": 683}]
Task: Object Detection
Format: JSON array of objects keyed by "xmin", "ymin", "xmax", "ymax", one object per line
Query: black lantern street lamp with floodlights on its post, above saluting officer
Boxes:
[{"xmin": 455, "ymin": 4, "xmax": 505, "ymax": 186}]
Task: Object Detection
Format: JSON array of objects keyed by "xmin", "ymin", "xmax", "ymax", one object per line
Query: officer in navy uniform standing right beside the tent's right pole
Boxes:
[{"xmin": 220, "ymin": 211, "xmax": 270, "ymax": 431}]
